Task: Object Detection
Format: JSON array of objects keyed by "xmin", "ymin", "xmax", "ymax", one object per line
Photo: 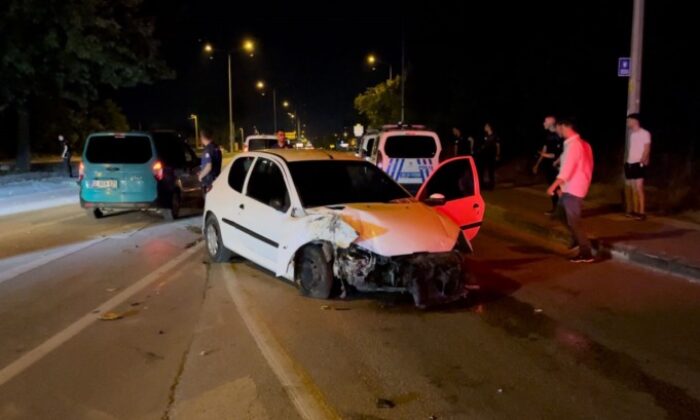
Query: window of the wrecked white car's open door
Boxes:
[{"xmin": 420, "ymin": 159, "xmax": 474, "ymax": 201}]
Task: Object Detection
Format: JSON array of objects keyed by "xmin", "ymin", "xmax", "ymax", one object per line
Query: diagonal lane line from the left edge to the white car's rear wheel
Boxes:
[{"xmin": 0, "ymin": 242, "xmax": 202, "ymax": 386}]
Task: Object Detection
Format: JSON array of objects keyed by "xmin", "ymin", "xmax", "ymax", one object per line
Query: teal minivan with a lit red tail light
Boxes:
[{"xmin": 79, "ymin": 130, "xmax": 204, "ymax": 220}]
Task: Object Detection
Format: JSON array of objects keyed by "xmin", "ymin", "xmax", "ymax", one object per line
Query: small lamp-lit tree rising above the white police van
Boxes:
[{"xmin": 355, "ymin": 76, "xmax": 401, "ymax": 127}]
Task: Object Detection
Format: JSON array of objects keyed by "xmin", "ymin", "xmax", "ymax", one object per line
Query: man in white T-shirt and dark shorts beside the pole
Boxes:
[{"xmin": 625, "ymin": 114, "xmax": 651, "ymax": 220}]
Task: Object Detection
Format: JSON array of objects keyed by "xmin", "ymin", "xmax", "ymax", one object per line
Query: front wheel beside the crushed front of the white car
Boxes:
[{"xmin": 294, "ymin": 245, "xmax": 333, "ymax": 299}]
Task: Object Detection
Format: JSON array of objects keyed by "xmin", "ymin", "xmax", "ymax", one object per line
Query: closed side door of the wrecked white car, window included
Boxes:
[{"xmin": 234, "ymin": 157, "xmax": 291, "ymax": 271}]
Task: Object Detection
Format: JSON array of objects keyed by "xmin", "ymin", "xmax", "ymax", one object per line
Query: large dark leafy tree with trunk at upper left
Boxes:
[{"xmin": 0, "ymin": 0, "xmax": 172, "ymax": 169}]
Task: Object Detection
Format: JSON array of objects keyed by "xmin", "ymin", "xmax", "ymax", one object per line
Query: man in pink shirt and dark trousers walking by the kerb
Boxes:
[{"xmin": 547, "ymin": 120, "xmax": 594, "ymax": 263}]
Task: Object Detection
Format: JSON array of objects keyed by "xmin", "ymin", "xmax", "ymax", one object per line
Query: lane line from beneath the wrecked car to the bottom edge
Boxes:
[{"xmin": 222, "ymin": 267, "xmax": 338, "ymax": 420}]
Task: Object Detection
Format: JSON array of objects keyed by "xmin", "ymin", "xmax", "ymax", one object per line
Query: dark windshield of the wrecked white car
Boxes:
[{"xmin": 288, "ymin": 160, "xmax": 411, "ymax": 208}]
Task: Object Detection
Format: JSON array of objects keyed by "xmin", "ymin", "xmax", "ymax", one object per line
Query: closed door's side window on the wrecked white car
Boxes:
[{"xmin": 246, "ymin": 158, "xmax": 291, "ymax": 213}]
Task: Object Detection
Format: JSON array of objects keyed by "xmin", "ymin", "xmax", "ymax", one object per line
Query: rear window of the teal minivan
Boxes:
[{"xmin": 85, "ymin": 136, "xmax": 153, "ymax": 163}]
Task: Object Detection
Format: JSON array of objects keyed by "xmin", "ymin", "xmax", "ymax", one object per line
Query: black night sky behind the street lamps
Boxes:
[{"xmin": 116, "ymin": 0, "xmax": 700, "ymax": 162}]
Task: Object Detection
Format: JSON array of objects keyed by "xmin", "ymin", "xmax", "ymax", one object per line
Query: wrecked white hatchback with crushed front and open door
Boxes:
[{"xmin": 203, "ymin": 150, "xmax": 484, "ymax": 306}]
